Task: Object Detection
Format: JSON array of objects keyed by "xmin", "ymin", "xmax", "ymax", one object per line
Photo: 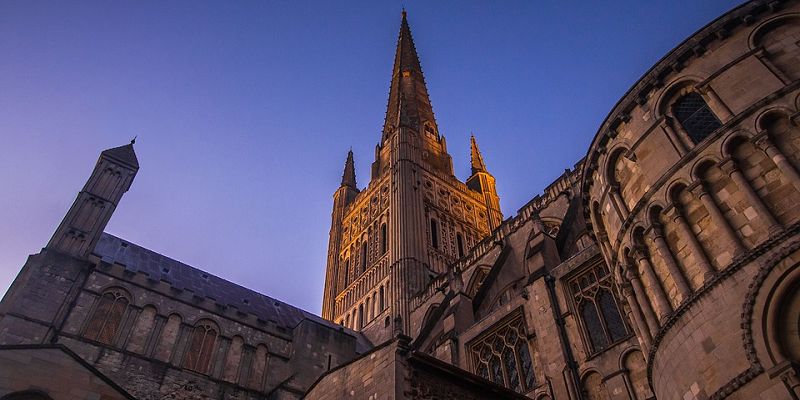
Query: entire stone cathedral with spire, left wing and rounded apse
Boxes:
[{"xmin": 0, "ymin": 0, "xmax": 800, "ymax": 400}]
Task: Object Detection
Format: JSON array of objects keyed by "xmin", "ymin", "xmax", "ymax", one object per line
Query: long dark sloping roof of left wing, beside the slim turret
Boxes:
[{"xmin": 94, "ymin": 232, "xmax": 372, "ymax": 353}]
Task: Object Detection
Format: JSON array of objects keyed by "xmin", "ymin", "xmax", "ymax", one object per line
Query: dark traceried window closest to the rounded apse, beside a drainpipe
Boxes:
[{"xmin": 570, "ymin": 263, "xmax": 629, "ymax": 353}]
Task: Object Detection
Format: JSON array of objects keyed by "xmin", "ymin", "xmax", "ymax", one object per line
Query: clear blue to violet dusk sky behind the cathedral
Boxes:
[{"xmin": 0, "ymin": 0, "xmax": 737, "ymax": 313}]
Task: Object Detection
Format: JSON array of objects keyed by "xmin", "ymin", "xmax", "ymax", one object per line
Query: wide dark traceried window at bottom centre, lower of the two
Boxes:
[{"xmin": 467, "ymin": 312, "xmax": 536, "ymax": 393}]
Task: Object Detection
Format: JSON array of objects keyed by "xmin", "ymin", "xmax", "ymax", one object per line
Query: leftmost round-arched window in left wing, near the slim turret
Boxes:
[{"xmin": 84, "ymin": 288, "xmax": 130, "ymax": 344}]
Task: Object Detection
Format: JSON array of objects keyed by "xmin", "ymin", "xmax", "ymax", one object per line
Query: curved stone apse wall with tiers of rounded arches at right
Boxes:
[{"xmin": 583, "ymin": 1, "xmax": 800, "ymax": 399}]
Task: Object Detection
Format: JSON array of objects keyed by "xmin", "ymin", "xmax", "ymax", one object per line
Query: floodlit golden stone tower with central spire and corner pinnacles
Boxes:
[{"xmin": 322, "ymin": 11, "xmax": 503, "ymax": 342}]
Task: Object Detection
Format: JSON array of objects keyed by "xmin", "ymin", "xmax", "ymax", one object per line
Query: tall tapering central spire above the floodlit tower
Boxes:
[{"xmin": 383, "ymin": 10, "xmax": 438, "ymax": 140}]
